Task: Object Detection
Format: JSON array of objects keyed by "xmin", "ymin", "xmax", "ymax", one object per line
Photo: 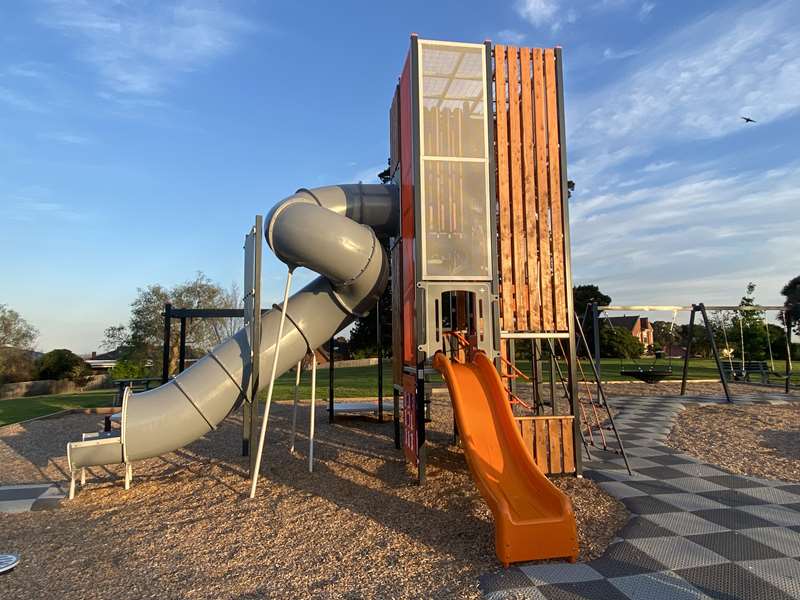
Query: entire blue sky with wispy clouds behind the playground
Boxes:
[{"xmin": 0, "ymin": 0, "xmax": 800, "ymax": 353}]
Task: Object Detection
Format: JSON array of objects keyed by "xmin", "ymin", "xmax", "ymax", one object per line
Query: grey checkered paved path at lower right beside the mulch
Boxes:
[{"xmin": 481, "ymin": 395, "xmax": 800, "ymax": 600}]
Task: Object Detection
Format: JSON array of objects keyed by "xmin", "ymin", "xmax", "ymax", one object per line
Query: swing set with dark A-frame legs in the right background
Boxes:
[{"xmin": 584, "ymin": 302, "xmax": 792, "ymax": 402}]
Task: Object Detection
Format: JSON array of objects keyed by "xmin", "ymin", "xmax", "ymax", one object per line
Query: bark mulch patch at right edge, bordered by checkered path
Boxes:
[{"xmin": 668, "ymin": 404, "xmax": 800, "ymax": 481}]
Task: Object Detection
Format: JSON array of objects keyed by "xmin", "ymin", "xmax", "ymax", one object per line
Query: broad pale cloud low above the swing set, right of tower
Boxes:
[{"xmin": 570, "ymin": 163, "xmax": 800, "ymax": 303}]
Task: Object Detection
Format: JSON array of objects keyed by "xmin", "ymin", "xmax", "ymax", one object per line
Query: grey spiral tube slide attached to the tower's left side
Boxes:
[{"xmin": 67, "ymin": 184, "xmax": 399, "ymax": 472}]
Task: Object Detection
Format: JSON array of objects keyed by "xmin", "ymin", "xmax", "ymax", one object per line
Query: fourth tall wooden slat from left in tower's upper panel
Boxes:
[{"xmin": 533, "ymin": 48, "xmax": 554, "ymax": 331}]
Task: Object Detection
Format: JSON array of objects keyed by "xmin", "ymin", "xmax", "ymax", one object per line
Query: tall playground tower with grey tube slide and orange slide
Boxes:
[{"xmin": 68, "ymin": 35, "xmax": 580, "ymax": 565}]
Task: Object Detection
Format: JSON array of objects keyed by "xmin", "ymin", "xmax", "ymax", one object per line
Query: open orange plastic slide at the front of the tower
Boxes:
[{"xmin": 433, "ymin": 352, "xmax": 578, "ymax": 566}]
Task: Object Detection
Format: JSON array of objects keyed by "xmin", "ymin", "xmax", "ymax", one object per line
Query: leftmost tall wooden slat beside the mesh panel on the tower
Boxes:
[{"xmin": 494, "ymin": 44, "xmax": 516, "ymax": 331}]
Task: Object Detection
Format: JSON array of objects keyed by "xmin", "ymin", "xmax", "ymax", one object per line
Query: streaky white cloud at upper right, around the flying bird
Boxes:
[{"xmin": 568, "ymin": 2, "xmax": 800, "ymax": 172}]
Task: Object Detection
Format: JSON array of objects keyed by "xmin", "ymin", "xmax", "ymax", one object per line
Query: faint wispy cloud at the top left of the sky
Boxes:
[{"xmin": 40, "ymin": 0, "xmax": 251, "ymax": 95}]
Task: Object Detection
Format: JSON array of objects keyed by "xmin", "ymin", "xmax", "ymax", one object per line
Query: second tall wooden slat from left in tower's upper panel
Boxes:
[{"xmin": 507, "ymin": 48, "xmax": 528, "ymax": 331}]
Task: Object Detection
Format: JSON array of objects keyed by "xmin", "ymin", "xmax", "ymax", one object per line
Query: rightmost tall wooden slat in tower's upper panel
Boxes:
[{"xmin": 544, "ymin": 48, "xmax": 568, "ymax": 331}]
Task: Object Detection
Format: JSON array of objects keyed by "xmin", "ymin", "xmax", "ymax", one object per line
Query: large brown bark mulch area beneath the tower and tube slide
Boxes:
[{"xmin": 0, "ymin": 398, "xmax": 627, "ymax": 600}]
